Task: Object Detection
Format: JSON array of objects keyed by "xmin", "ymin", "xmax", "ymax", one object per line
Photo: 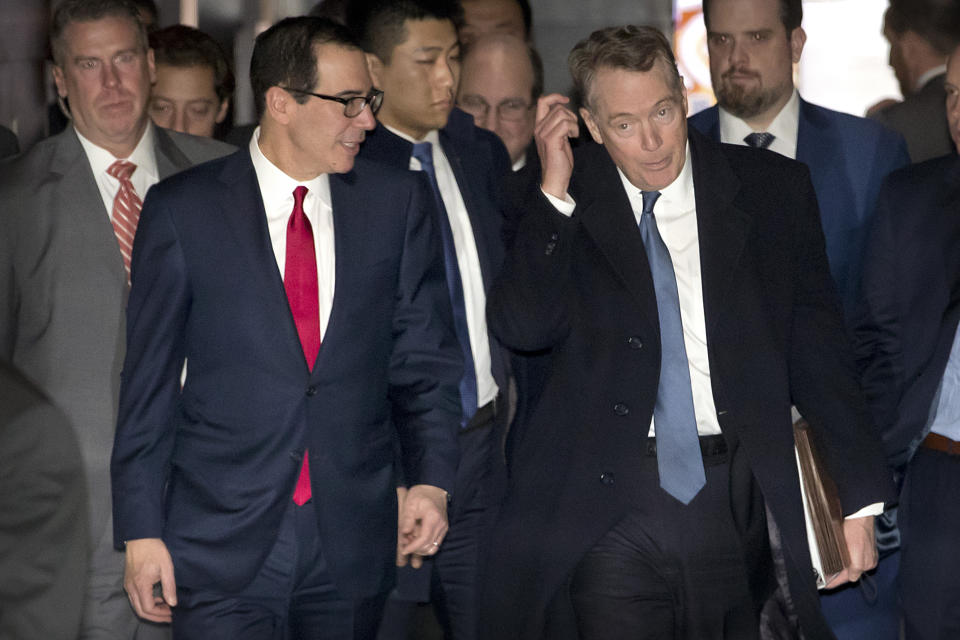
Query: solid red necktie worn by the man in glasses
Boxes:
[{"xmin": 283, "ymin": 186, "xmax": 320, "ymax": 505}]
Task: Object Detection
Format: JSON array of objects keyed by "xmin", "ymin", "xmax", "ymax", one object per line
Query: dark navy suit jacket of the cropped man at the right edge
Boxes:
[{"xmin": 854, "ymin": 153, "xmax": 960, "ymax": 466}]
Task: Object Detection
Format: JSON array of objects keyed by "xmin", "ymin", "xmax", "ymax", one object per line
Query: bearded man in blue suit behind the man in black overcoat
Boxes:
[{"xmin": 690, "ymin": 0, "xmax": 910, "ymax": 320}]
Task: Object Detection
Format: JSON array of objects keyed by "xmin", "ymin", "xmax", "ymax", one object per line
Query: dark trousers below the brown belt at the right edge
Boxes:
[{"xmin": 898, "ymin": 447, "xmax": 960, "ymax": 640}]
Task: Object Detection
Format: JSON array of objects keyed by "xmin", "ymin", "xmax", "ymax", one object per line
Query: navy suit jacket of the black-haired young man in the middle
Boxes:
[{"xmin": 360, "ymin": 109, "xmax": 510, "ymax": 402}]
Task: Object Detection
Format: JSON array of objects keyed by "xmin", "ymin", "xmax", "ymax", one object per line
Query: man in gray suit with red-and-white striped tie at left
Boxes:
[{"xmin": 0, "ymin": 0, "xmax": 231, "ymax": 640}]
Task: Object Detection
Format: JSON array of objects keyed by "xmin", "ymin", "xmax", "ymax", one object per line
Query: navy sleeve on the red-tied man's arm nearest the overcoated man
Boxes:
[{"xmin": 390, "ymin": 177, "xmax": 463, "ymax": 493}]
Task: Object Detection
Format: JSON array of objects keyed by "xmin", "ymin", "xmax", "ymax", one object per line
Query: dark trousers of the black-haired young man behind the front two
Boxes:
[{"xmin": 377, "ymin": 416, "xmax": 502, "ymax": 640}]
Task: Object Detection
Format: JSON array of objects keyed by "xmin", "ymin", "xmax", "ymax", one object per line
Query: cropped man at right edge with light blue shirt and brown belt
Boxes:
[{"xmin": 854, "ymin": 49, "xmax": 960, "ymax": 640}]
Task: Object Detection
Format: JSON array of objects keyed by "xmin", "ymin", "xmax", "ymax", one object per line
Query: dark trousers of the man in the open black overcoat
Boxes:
[{"xmin": 570, "ymin": 436, "xmax": 769, "ymax": 640}]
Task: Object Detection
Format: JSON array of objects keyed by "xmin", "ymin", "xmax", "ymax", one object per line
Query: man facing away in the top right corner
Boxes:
[{"xmin": 868, "ymin": 0, "xmax": 960, "ymax": 162}]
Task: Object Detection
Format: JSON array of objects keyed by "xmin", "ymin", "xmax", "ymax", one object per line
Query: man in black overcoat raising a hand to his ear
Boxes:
[{"xmin": 483, "ymin": 26, "xmax": 893, "ymax": 640}]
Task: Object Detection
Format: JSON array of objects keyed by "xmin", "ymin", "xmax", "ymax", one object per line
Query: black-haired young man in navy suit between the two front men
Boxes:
[{"xmin": 352, "ymin": 0, "xmax": 510, "ymax": 640}]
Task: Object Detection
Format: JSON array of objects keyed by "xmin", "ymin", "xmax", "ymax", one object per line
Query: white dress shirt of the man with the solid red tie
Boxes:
[{"xmin": 250, "ymin": 127, "xmax": 336, "ymax": 341}]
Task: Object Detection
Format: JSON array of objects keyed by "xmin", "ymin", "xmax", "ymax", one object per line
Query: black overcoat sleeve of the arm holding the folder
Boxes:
[{"xmin": 789, "ymin": 168, "xmax": 895, "ymax": 514}]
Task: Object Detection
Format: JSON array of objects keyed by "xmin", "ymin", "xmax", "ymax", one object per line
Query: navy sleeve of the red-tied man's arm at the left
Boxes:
[{"xmin": 111, "ymin": 188, "xmax": 190, "ymax": 548}]
